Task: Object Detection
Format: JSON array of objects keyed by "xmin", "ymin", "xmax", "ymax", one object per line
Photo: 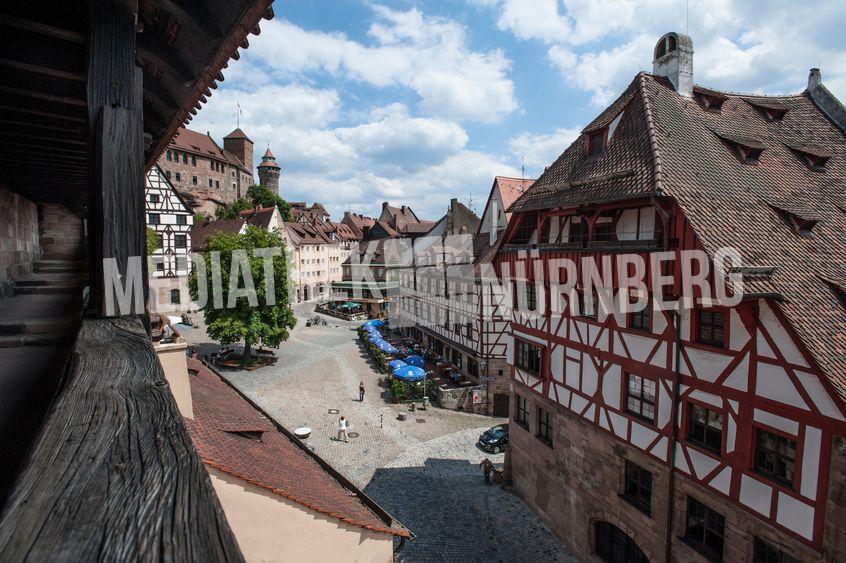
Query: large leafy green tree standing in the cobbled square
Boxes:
[{"xmin": 188, "ymin": 226, "xmax": 296, "ymax": 363}]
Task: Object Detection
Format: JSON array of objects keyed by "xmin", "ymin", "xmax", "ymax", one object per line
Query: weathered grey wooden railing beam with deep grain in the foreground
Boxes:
[{"xmin": 0, "ymin": 319, "xmax": 242, "ymax": 561}]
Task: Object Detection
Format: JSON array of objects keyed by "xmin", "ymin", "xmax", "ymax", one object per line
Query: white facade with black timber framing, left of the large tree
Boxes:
[{"xmin": 149, "ymin": 166, "xmax": 194, "ymax": 312}]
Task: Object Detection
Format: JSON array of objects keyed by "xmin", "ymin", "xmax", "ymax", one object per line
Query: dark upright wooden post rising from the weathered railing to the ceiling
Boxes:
[{"xmin": 86, "ymin": 0, "xmax": 149, "ymax": 322}]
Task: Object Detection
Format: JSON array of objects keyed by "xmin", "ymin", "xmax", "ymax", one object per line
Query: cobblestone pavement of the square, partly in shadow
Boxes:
[{"xmin": 183, "ymin": 305, "xmax": 566, "ymax": 561}]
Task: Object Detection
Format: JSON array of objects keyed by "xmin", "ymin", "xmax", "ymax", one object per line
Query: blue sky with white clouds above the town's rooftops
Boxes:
[{"xmin": 191, "ymin": 0, "xmax": 846, "ymax": 219}]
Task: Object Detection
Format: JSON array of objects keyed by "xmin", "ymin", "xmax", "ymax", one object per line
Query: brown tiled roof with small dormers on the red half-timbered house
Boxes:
[{"xmin": 511, "ymin": 73, "xmax": 846, "ymax": 398}]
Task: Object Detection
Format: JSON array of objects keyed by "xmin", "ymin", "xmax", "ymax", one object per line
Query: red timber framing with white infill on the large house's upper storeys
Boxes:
[{"xmin": 495, "ymin": 196, "xmax": 846, "ymax": 551}]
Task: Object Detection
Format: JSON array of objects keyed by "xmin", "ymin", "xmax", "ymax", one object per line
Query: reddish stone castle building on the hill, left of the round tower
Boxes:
[{"xmin": 158, "ymin": 127, "xmax": 253, "ymax": 216}]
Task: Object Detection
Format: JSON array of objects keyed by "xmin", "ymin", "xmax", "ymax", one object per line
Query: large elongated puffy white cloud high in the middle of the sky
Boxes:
[{"xmin": 247, "ymin": 6, "xmax": 518, "ymax": 122}]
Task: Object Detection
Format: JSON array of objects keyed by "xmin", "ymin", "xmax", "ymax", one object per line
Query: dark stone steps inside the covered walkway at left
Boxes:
[{"xmin": 0, "ymin": 260, "xmax": 87, "ymax": 348}]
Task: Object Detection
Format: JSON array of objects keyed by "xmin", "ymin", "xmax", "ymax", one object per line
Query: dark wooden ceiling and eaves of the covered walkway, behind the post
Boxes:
[{"xmin": 0, "ymin": 0, "xmax": 273, "ymax": 214}]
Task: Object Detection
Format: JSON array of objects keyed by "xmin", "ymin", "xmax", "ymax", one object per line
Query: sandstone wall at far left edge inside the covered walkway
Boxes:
[{"xmin": 0, "ymin": 186, "xmax": 41, "ymax": 301}]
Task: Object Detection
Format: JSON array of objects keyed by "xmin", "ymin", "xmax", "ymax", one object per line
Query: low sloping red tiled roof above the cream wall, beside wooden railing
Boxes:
[{"xmin": 184, "ymin": 358, "xmax": 410, "ymax": 537}]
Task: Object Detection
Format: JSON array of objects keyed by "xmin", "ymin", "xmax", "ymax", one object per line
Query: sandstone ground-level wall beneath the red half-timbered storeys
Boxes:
[{"xmin": 508, "ymin": 382, "xmax": 846, "ymax": 563}]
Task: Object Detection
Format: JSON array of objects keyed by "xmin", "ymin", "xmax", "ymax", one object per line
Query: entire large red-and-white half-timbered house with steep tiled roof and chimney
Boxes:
[{"xmin": 495, "ymin": 33, "xmax": 846, "ymax": 561}]
